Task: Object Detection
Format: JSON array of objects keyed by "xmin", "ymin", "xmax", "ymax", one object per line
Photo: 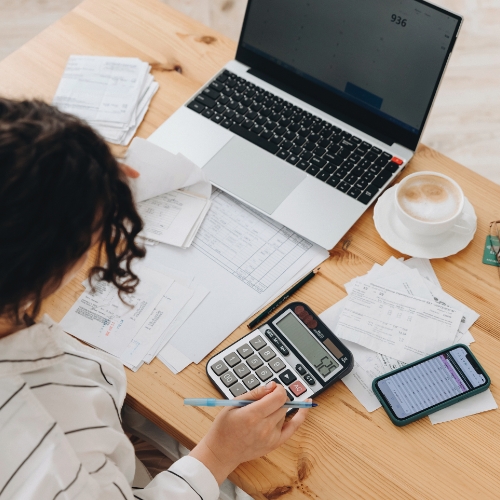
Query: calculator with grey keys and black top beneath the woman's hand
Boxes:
[{"xmin": 206, "ymin": 302, "xmax": 354, "ymax": 401}]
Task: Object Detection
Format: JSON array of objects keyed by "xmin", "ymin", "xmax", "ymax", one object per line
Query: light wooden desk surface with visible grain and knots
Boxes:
[{"xmin": 0, "ymin": 0, "xmax": 500, "ymax": 500}]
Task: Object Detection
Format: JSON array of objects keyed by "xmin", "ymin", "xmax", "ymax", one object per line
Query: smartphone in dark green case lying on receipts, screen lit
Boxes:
[{"xmin": 372, "ymin": 344, "xmax": 491, "ymax": 426}]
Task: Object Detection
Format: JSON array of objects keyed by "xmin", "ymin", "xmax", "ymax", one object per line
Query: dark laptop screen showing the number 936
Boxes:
[{"xmin": 240, "ymin": 0, "xmax": 461, "ymax": 146}]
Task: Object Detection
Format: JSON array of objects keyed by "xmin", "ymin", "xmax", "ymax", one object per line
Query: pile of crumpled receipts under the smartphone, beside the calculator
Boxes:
[{"xmin": 321, "ymin": 257, "xmax": 497, "ymax": 423}]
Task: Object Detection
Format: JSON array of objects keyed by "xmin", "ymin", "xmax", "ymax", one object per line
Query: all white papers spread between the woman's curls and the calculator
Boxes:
[{"xmin": 61, "ymin": 186, "xmax": 329, "ymax": 373}]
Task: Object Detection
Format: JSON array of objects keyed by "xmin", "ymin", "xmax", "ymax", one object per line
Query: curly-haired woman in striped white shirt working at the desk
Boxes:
[{"xmin": 0, "ymin": 99, "xmax": 306, "ymax": 500}]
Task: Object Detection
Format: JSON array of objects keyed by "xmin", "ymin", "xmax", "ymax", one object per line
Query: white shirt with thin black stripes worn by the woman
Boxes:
[{"xmin": 0, "ymin": 316, "xmax": 219, "ymax": 500}]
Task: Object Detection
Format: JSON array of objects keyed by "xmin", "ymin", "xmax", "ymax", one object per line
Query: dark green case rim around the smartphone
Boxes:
[{"xmin": 372, "ymin": 344, "xmax": 491, "ymax": 427}]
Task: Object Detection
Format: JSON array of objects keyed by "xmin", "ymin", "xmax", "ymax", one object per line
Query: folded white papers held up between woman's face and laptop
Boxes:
[{"xmin": 125, "ymin": 138, "xmax": 212, "ymax": 248}]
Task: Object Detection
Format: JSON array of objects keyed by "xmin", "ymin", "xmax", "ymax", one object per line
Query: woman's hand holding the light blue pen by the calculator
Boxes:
[{"xmin": 190, "ymin": 382, "xmax": 308, "ymax": 484}]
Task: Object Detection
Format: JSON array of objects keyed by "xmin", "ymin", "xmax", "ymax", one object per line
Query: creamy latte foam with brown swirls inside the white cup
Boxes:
[{"xmin": 398, "ymin": 175, "xmax": 461, "ymax": 222}]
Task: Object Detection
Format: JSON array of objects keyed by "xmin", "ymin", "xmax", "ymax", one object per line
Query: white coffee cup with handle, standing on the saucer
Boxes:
[{"xmin": 394, "ymin": 171, "xmax": 476, "ymax": 236}]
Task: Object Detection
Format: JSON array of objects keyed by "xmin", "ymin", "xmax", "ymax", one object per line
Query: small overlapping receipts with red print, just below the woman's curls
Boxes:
[{"xmin": 61, "ymin": 263, "xmax": 208, "ymax": 371}]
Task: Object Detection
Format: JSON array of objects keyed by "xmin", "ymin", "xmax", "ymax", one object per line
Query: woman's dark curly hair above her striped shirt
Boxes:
[{"xmin": 0, "ymin": 99, "xmax": 145, "ymax": 321}]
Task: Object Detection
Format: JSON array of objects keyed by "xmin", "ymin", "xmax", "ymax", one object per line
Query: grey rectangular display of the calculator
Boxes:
[{"xmin": 275, "ymin": 313, "xmax": 340, "ymax": 379}]
